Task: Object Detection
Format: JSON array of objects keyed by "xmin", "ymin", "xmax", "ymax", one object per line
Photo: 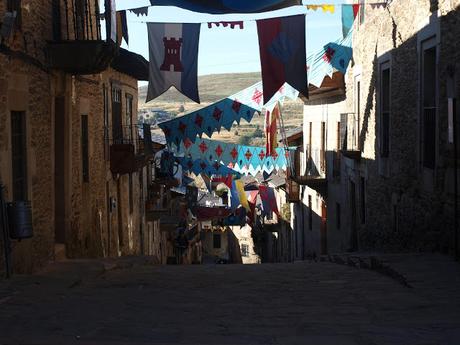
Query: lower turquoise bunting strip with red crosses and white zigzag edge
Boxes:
[{"xmin": 172, "ymin": 138, "xmax": 289, "ymax": 176}]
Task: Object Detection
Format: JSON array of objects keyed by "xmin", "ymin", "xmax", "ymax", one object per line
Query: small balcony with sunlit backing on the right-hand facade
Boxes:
[{"xmin": 340, "ymin": 113, "xmax": 361, "ymax": 161}]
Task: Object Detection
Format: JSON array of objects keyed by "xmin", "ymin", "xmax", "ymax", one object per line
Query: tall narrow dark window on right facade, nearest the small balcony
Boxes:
[{"xmin": 380, "ymin": 62, "xmax": 390, "ymax": 158}]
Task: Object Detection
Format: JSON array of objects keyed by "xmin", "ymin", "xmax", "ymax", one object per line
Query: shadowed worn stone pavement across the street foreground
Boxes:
[{"xmin": 0, "ymin": 255, "xmax": 460, "ymax": 345}]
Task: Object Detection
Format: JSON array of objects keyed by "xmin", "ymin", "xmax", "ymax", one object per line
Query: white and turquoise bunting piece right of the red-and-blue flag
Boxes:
[{"xmin": 307, "ymin": 28, "xmax": 353, "ymax": 88}]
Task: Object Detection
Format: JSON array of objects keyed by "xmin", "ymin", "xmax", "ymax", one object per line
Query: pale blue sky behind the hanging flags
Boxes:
[{"xmin": 111, "ymin": 0, "xmax": 346, "ymax": 75}]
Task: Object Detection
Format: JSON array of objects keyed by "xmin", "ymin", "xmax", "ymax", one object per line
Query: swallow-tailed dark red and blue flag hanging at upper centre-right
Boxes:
[{"xmin": 257, "ymin": 14, "xmax": 308, "ymax": 104}]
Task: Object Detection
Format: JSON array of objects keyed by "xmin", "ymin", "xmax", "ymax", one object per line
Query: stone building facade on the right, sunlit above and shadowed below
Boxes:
[{"xmin": 294, "ymin": 0, "xmax": 460, "ymax": 255}]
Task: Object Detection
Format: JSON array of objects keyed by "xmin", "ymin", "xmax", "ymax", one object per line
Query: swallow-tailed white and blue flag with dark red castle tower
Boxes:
[{"xmin": 146, "ymin": 23, "xmax": 201, "ymax": 103}]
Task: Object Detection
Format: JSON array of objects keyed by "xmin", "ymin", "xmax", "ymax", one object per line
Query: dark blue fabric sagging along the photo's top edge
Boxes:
[{"xmin": 146, "ymin": 0, "xmax": 302, "ymax": 14}]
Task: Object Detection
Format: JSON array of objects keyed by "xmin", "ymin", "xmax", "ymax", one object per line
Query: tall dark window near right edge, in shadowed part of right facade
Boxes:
[{"xmin": 421, "ymin": 40, "xmax": 437, "ymax": 169}]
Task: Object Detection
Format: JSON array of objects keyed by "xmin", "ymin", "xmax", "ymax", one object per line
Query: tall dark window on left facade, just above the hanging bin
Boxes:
[{"xmin": 11, "ymin": 111, "xmax": 28, "ymax": 200}]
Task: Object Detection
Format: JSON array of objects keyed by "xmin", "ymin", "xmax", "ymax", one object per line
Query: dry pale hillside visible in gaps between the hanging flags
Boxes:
[{"xmin": 139, "ymin": 73, "xmax": 303, "ymax": 146}]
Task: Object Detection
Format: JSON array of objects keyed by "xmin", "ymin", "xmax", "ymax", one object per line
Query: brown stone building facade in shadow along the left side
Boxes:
[{"xmin": 0, "ymin": 1, "xmax": 155, "ymax": 273}]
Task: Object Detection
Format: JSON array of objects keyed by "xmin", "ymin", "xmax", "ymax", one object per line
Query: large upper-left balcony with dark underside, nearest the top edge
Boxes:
[{"xmin": 46, "ymin": 0, "xmax": 118, "ymax": 75}]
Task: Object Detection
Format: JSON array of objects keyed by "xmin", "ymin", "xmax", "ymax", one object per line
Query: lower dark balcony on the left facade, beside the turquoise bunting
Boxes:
[{"xmin": 105, "ymin": 126, "xmax": 153, "ymax": 175}]
